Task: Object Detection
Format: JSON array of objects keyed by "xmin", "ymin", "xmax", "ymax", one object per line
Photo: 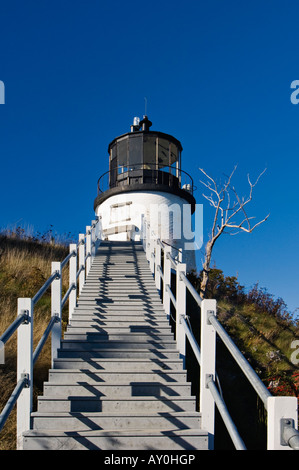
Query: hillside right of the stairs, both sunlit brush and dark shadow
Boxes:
[{"xmin": 188, "ymin": 269, "xmax": 299, "ymax": 449}]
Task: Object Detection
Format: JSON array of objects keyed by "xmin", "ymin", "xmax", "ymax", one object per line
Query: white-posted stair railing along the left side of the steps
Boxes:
[{"xmin": 0, "ymin": 219, "xmax": 101, "ymax": 450}]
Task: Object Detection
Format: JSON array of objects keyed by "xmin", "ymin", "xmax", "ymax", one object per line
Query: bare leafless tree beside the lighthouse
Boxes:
[{"xmin": 199, "ymin": 166, "xmax": 270, "ymax": 298}]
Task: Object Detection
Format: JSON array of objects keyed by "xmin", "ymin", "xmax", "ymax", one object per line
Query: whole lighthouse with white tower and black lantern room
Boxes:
[{"xmin": 94, "ymin": 116, "xmax": 196, "ymax": 270}]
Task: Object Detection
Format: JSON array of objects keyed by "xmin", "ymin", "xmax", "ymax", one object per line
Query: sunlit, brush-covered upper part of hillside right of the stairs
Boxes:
[{"xmin": 192, "ymin": 269, "xmax": 299, "ymax": 380}]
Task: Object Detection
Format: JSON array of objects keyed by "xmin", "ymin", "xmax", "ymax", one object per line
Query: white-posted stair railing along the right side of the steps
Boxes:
[{"xmin": 141, "ymin": 218, "xmax": 299, "ymax": 450}]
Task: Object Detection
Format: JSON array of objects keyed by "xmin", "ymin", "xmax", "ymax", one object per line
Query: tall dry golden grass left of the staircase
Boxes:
[{"xmin": 0, "ymin": 237, "xmax": 68, "ymax": 450}]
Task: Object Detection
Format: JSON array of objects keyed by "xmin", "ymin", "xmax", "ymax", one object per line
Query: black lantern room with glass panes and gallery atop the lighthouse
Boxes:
[{"xmin": 95, "ymin": 116, "xmax": 195, "ymax": 212}]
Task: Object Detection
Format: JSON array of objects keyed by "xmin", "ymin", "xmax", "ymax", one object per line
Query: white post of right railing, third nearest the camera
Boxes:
[{"xmin": 176, "ymin": 263, "xmax": 186, "ymax": 368}]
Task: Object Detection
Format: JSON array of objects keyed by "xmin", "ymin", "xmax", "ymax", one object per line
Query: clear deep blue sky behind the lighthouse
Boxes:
[{"xmin": 0, "ymin": 0, "xmax": 299, "ymax": 318}]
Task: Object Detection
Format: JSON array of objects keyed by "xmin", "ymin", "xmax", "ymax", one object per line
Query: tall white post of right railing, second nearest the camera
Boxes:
[{"xmin": 200, "ymin": 299, "xmax": 216, "ymax": 450}]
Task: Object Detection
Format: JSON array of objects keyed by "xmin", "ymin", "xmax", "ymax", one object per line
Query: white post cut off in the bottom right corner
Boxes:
[{"xmin": 267, "ymin": 396, "xmax": 298, "ymax": 450}]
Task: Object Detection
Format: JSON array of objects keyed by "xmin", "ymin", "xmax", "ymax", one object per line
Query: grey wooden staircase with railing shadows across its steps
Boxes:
[{"xmin": 24, "ymin": 242, "xmax": 208, "ymax": 451}]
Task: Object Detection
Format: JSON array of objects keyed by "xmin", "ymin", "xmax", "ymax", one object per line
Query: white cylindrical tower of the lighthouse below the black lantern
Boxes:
[{"xmin": 96, "ymin": 191, "xmax": 196, "ymax": 271}]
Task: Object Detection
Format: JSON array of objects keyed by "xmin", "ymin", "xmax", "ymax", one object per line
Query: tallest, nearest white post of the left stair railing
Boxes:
[{"xmin": 17, "ymin": 298, "xmax": 33, "ymax": 450}]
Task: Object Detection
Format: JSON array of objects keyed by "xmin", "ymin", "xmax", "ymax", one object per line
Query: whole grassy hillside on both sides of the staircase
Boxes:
[{"xmin": 0, "ymin": 230, "xmax": 299, "ymax": 450}]
